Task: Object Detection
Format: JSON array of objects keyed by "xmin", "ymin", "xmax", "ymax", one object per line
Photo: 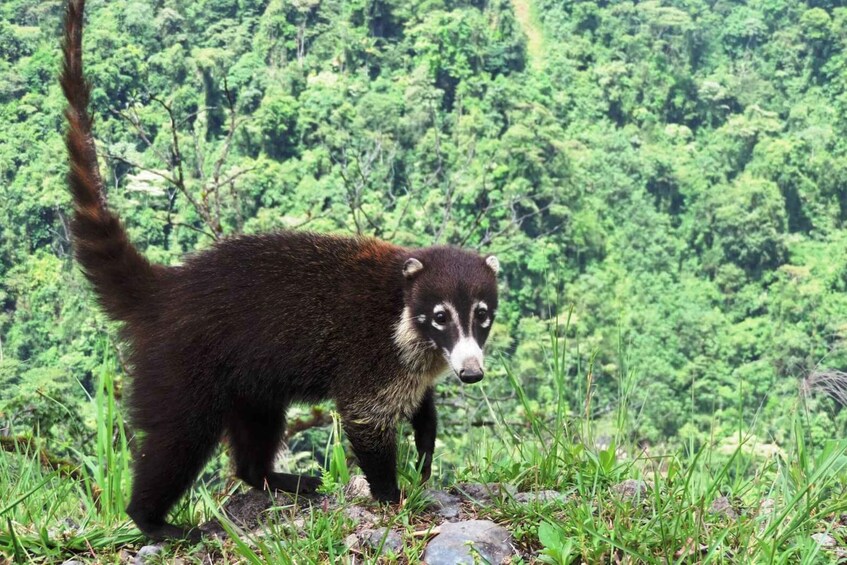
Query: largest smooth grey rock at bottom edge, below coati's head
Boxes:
[{"xmin": 424, "ymin": 520, "xmax": 513, "ymax": 565}]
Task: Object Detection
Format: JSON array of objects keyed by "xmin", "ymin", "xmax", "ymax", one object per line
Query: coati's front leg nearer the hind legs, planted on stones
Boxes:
[{"xmin": 343, "ymin": 415, "xmax": 400, "ymax": 503}]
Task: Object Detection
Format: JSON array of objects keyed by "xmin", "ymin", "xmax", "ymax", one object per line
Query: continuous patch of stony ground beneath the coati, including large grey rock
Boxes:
[{"xmin": 69, "ymin": 476, "xmax": 565, "ymax": 565}]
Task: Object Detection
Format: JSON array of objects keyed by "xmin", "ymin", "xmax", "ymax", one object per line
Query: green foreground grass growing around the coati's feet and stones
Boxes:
[{"xmin": 0, "ymin": 346, "xmax": 847, "ymax": 563}]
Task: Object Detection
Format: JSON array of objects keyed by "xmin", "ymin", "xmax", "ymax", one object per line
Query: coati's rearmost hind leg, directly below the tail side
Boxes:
[{"xmin": 126, "ymin": 417, "xmax": 220, "ymax": 541}]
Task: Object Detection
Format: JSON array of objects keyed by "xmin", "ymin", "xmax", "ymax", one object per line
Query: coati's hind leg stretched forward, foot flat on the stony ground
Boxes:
[{"xmin": 229, "ymin": 403, "xmax": 321, "ymax": 494}]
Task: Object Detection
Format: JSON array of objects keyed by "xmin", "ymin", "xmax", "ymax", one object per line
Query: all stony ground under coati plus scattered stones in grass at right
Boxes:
[{"xmin": 56, "ymin": 476, "xmax": 847, "ymax": 565}]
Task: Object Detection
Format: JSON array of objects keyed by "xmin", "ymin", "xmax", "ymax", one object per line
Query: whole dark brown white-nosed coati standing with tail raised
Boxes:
[{"xmin": 61, "ymin": 0, "xmax": 499, "ymax": 538}]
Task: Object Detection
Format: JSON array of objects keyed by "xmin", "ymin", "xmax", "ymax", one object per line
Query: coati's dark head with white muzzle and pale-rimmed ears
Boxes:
[{"xmin": 396, "ymin": 247, "xmax": 500, "ymax": 383}]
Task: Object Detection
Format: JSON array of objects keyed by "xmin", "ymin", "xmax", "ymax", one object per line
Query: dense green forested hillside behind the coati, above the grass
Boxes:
[{"xmin": 0, "ymin": 0, "xmax": 847, "ymax": 458}]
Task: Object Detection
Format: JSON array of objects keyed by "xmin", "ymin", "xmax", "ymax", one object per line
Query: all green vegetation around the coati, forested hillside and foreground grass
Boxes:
[{"xmin": 0, "ymin": 0, "xmax": 847, "ymax": 563}]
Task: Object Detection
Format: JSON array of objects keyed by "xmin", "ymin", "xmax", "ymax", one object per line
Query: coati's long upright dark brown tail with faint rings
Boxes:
[{"xmin": 59, "ymin": 0, "xmax": 160, "ymax": 321}]
